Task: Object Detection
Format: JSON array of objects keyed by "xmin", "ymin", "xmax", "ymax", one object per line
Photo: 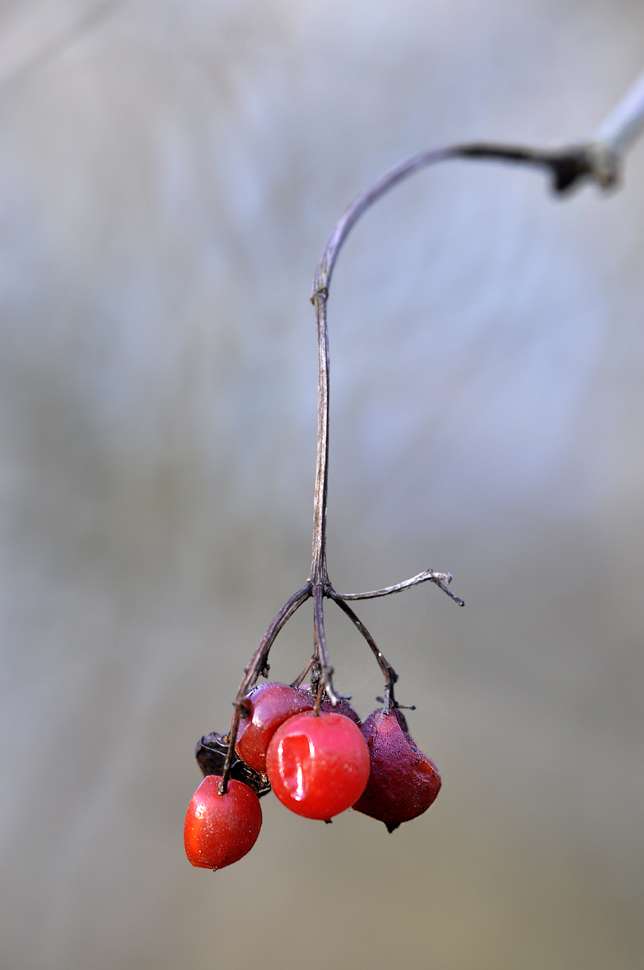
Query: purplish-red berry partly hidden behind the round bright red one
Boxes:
[{"xmin": 235, "ymin": 683, "xmax": 315, "ymax": 775}]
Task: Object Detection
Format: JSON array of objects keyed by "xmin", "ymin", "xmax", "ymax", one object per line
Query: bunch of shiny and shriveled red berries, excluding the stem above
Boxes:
[{"xmin": 184, "ymin": 683, "xmax": 441, "ymax": 869}]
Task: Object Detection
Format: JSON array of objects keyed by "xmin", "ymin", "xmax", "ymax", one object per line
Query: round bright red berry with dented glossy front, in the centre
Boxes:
[{"xmin": 266, "ymin": 712, "xmax": 369, "ymax": 821}]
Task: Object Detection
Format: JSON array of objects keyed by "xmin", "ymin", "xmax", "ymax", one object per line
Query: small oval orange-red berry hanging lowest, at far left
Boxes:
[{"xmin": 183, "ymin": 775, "xmax": 262, "ymax": 869}]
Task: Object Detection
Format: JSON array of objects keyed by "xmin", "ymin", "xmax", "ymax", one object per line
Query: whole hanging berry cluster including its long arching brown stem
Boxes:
[{"xmin": 180, "ymin": 113, "xmax": 624, "ymax": 869}]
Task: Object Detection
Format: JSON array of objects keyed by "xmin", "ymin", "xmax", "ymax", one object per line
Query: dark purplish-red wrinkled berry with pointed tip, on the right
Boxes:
[{"xmin": 353, "ymin": 708, "xmax": 441, "ymax": 832}]
